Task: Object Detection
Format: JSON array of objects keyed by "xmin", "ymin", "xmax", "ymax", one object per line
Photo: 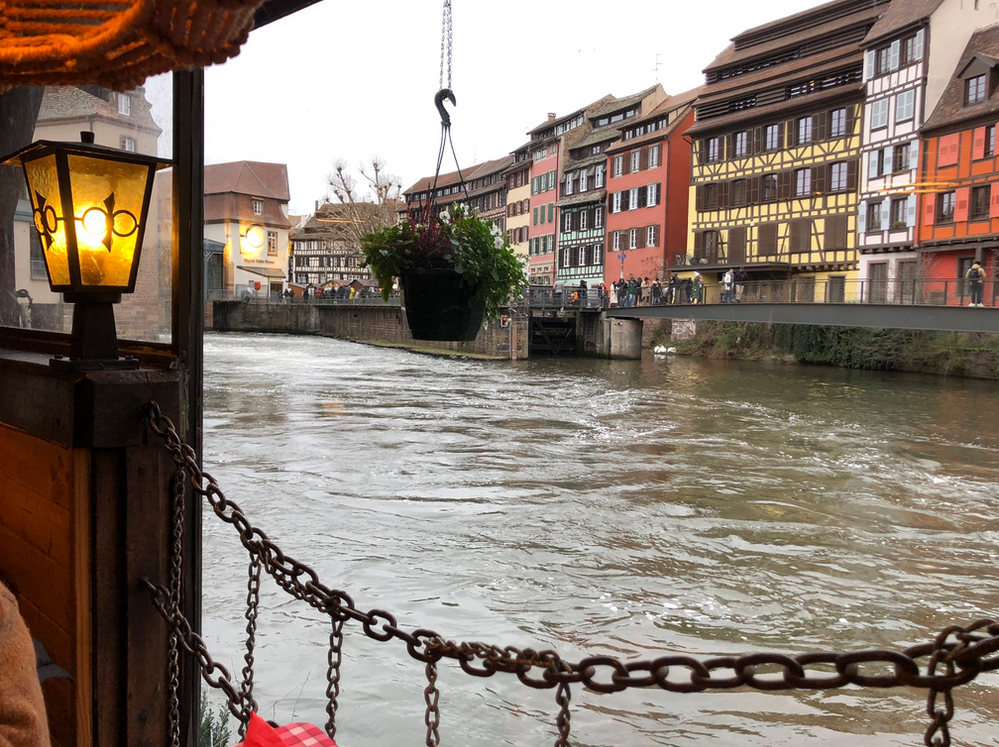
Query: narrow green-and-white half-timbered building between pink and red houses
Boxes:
[{"xmin": 557, "ymin": 84, "xmax": 666, "ymax": 285}]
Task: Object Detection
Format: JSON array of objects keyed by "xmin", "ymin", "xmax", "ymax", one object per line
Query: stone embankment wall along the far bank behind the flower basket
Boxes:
[{"xmin": 212, "ymin": 301, "xmax": 528, "ymax": 359}]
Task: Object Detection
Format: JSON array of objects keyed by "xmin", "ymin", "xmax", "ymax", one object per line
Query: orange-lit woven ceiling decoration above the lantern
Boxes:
[{"xmin": 0, "ymin": 0, "xmax": 264, "ymax": 91}]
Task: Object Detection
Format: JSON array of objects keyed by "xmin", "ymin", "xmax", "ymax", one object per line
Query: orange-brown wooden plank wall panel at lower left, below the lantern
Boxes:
[{"xmin": 0, "ymin": 424, "xmax": 91, "ymax": 747}]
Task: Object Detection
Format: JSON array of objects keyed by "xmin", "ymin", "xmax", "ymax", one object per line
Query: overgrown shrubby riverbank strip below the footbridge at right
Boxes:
[{"xmin": 672, "ymin": 322, "xmax": 999, "ymax": 379}]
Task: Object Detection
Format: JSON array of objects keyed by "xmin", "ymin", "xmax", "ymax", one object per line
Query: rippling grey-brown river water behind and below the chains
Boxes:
[{"xmin": 204, "ymin": 334, "xmax": 999, "ymax": 747}]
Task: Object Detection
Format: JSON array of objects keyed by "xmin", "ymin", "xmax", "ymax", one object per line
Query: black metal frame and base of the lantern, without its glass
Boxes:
[{"xmin": 0, "ymin": 132, "xmax": 172, "ymax": 371}]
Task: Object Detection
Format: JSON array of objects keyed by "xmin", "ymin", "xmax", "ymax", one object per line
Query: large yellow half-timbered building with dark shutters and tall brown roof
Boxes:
[{"xmin": 688, "ymin": 0, "xmax": 888, "ymax": 300}]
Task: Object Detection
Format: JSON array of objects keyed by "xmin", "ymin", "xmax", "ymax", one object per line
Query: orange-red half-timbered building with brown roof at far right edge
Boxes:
[{"xmin": 917, "ymin": 26, "xmax": 999, "ymax": 306}]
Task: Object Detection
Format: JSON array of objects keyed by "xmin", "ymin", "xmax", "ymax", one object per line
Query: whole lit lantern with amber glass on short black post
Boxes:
[{"xmin": 3, "ymin": 132, "xmax": 169, "ymax": 371}]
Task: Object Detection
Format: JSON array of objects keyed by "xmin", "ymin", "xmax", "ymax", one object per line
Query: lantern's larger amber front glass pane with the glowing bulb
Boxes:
[{"xmin": 68, "ymin": 155, "xmax": 150, "ymax": 288}]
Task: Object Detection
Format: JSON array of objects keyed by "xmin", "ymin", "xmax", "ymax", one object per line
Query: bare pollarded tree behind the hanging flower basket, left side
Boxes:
[{"xmin": 326, "ymin": 156, "xmax": 402, "ymax": 245}]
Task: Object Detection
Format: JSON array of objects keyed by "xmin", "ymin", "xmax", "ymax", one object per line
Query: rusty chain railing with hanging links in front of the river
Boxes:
[{"xmin": 146, "ymin": 403, "xmax": 999, "ymax": 747}]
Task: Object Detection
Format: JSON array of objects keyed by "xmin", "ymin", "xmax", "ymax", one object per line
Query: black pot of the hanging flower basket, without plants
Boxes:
[{"xmin": 399, "ymin": 269, "xmax": 486, "ymax": 342}]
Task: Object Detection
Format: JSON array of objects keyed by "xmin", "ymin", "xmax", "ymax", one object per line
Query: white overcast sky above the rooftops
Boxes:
[{"xmin": 205, "ymin": 0, "xmax": 820, "ymax": 213}]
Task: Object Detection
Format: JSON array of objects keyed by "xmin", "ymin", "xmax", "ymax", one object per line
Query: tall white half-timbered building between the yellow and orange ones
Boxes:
[{"xmin": 857, "ymin": 0, "xmax": 985, "ymax": 303}]
